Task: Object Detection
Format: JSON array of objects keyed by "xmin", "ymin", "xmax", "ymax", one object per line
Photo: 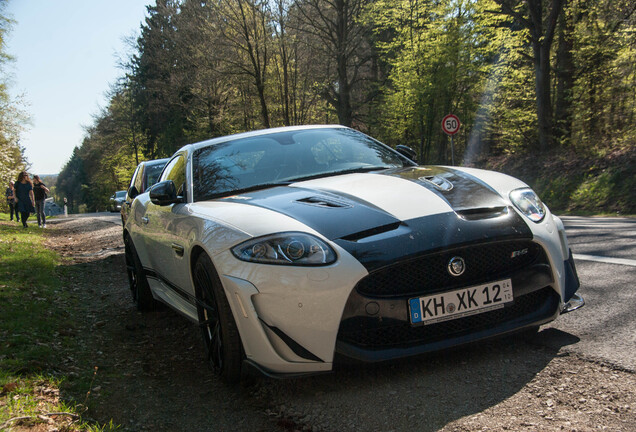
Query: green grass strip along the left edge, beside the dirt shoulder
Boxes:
[{"xmin": 0, "ymin": 213, "xmax": 117, "ymax": 431}]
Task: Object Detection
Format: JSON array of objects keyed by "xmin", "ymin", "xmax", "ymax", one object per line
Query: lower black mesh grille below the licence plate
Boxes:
[{"xmin": 338, "ymin": 287, "xmax": 559, "ymax": 349}]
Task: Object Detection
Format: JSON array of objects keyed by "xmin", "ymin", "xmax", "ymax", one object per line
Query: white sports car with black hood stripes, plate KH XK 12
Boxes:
[{"xmin": 124, "ymin": 126, "xmax": 583, "ymax": 382}]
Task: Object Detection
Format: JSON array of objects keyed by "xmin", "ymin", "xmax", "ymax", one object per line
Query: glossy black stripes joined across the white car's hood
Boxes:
[{"xmin": 224, "ymin": 170, "xmax": 532, "ymax": 256}]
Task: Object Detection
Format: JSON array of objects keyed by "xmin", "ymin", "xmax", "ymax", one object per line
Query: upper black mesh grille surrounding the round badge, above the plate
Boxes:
[{"xmin": 356, "ymin": 240, "xmax": 547, "ymax": 297}]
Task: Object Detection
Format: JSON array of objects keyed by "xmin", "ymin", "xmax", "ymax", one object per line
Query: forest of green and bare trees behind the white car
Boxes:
[{"xmin": 0, "ymin": 0, "xmax": 636, "ymax": 213}]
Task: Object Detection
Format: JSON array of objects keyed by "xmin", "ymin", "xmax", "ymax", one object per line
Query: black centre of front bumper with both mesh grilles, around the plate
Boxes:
[{"xmin": 336, "ymin": 241, "xmax": 561, "ymax": 362}]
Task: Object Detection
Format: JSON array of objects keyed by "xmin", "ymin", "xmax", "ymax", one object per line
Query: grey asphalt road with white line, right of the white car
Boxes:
[{"xmin": 538, "ymin": 216, "xmax": 636, "ymax": 371}]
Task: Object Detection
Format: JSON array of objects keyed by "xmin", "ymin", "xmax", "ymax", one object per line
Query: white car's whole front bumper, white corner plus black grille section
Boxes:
[{"xmin": 222, "ymin": 238, "xmax": 578, "ymax": 376}]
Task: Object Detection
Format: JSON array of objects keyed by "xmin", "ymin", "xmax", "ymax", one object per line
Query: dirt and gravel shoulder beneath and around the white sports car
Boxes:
[{"xmin": 42, "ymin": 218, "xmax": 636, "ymax": 432}]
